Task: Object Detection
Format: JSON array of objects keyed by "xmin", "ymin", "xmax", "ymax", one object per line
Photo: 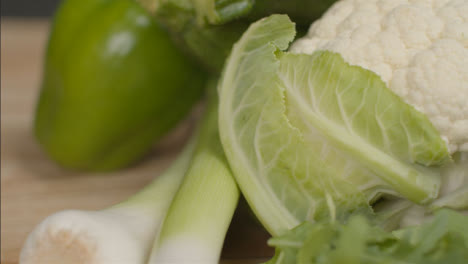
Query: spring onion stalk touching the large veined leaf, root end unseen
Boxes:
[{"xmin": 149, "ymin": 91, "xmax": 239, "ymax": 264}]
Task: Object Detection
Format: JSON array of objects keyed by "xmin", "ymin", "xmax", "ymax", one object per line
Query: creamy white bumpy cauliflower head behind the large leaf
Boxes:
[{"xmin": 291, "ymin": 0, "xmax": 468, "ymax": 153}]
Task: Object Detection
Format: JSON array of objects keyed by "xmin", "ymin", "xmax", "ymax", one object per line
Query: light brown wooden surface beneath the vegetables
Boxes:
[{"xmin": 1, "ymin": 19, "xmax": 273, "ymax": 264}]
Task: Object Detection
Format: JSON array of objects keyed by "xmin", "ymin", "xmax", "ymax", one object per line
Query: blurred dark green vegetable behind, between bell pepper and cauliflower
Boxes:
[{"xmin": 138, "ymin": 0, "xmax": 336, "ymax": 71}]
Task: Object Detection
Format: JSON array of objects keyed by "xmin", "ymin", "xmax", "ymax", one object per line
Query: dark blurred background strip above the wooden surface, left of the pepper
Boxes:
[{"xmin": 1, "ymin": 0, "xmax": 61, "ymax": 17}]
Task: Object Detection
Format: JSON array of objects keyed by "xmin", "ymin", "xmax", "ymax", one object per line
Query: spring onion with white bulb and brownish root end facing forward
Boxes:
[{"xmin": 20, "ymin": 136, "xmax": 196, "ymax": 264}]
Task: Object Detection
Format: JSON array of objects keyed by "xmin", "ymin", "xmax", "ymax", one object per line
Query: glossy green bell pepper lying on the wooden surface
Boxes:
[{"xmin": 35, "ymin": 0, "xmax": 206, "ymax": 170}]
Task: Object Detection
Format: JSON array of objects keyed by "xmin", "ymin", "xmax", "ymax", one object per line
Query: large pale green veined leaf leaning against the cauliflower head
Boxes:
[{"xmin": 218, "ymin": 15, "xmax": 450, "ymax": 235}]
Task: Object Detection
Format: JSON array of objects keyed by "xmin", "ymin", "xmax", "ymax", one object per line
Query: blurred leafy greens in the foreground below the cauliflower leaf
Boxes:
[{"xmin": 267, "ymin": 210, "xmax": 468, "ymax": 264}]
